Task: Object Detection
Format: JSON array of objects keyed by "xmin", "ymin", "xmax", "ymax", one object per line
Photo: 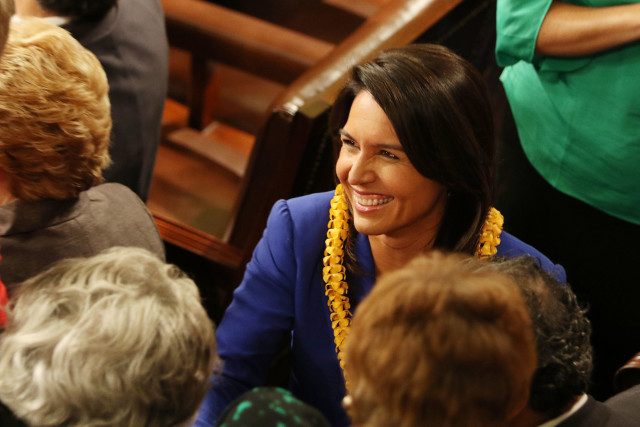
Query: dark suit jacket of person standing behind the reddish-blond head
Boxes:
[{"xmin": 64, "ymin": 0, "xmax": 169, "ymax": 200}]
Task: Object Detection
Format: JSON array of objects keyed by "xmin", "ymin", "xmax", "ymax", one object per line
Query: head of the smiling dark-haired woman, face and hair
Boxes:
[{"xmin": 330, "ymin": 44, "xmax": 496, "ymax": 253}]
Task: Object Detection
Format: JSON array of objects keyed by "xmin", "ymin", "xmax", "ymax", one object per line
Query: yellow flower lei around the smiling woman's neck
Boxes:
[{"xmin": 322, "ymin": 184, "xmax": 504, "ymax": 382}]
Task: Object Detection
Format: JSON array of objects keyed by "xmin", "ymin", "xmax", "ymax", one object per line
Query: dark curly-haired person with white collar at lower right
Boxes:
[{"xmin": 478, "ymin": 257, "xmax": 639, "ymax": 427}]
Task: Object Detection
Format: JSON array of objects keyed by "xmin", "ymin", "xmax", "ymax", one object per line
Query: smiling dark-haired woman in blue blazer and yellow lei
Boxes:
[{"xmin": 197, "ymin": 45, "xmax": 565, "ymax": 426}]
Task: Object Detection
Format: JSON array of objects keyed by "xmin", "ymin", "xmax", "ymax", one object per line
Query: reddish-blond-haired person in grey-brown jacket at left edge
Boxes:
[{"xmin": 0, "ymin": 18, "xmax": 164, "ymax": 294}]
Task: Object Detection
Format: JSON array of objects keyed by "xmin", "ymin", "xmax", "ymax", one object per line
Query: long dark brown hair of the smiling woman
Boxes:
[{"xmin": 329, "ymin": 44, "xmax": 496, "ymax": 254}]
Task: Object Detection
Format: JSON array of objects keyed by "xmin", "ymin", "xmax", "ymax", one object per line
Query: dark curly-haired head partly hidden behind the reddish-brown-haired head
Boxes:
[{"xmin": 488, "ymin": 257, "xmax": 593, "ymax": 418}]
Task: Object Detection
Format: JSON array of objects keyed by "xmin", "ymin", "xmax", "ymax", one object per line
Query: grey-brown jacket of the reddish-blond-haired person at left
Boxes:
[{"xmin": 0, "ymin": 183, "xmax": 164, "ymax": 294}]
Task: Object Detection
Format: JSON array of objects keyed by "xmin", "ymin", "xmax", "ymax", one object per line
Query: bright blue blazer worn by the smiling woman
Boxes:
[{"xmin": 196, "ymin": 192, "xmax": 565, "ymax": 426}]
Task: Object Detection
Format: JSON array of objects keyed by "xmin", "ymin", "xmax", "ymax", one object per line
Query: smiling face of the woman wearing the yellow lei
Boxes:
[{"xmin": 336, "ymin": 91, "xmax": 446, "ymax": 238}]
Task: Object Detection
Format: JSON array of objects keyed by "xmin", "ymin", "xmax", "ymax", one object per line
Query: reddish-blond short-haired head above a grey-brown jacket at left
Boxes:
[{"xmin": 0, "ymin": 18, "xmax": 111, "ymax": 201}]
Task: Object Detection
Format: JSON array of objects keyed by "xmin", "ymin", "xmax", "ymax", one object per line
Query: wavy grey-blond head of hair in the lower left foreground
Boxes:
[{"xmin": 0, "ymin": 248, "xmax": 217, "ymax": 426}]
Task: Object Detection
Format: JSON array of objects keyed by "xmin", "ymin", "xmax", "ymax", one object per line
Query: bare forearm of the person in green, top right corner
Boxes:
[{"xmin": 536, "ymin": 1, "xmax": 640, "ymax": 56}]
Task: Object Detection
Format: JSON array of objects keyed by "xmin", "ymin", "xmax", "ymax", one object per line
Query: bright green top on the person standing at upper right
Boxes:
[{"xmin": 496, "ymin": 0, "xmax": 640, "ymax": 225}]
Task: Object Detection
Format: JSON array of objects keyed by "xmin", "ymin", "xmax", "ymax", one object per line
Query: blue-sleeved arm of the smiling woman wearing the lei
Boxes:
[{"xmin": 194, "ymin": 200, "xmax": 296, "ymax": 427}]
